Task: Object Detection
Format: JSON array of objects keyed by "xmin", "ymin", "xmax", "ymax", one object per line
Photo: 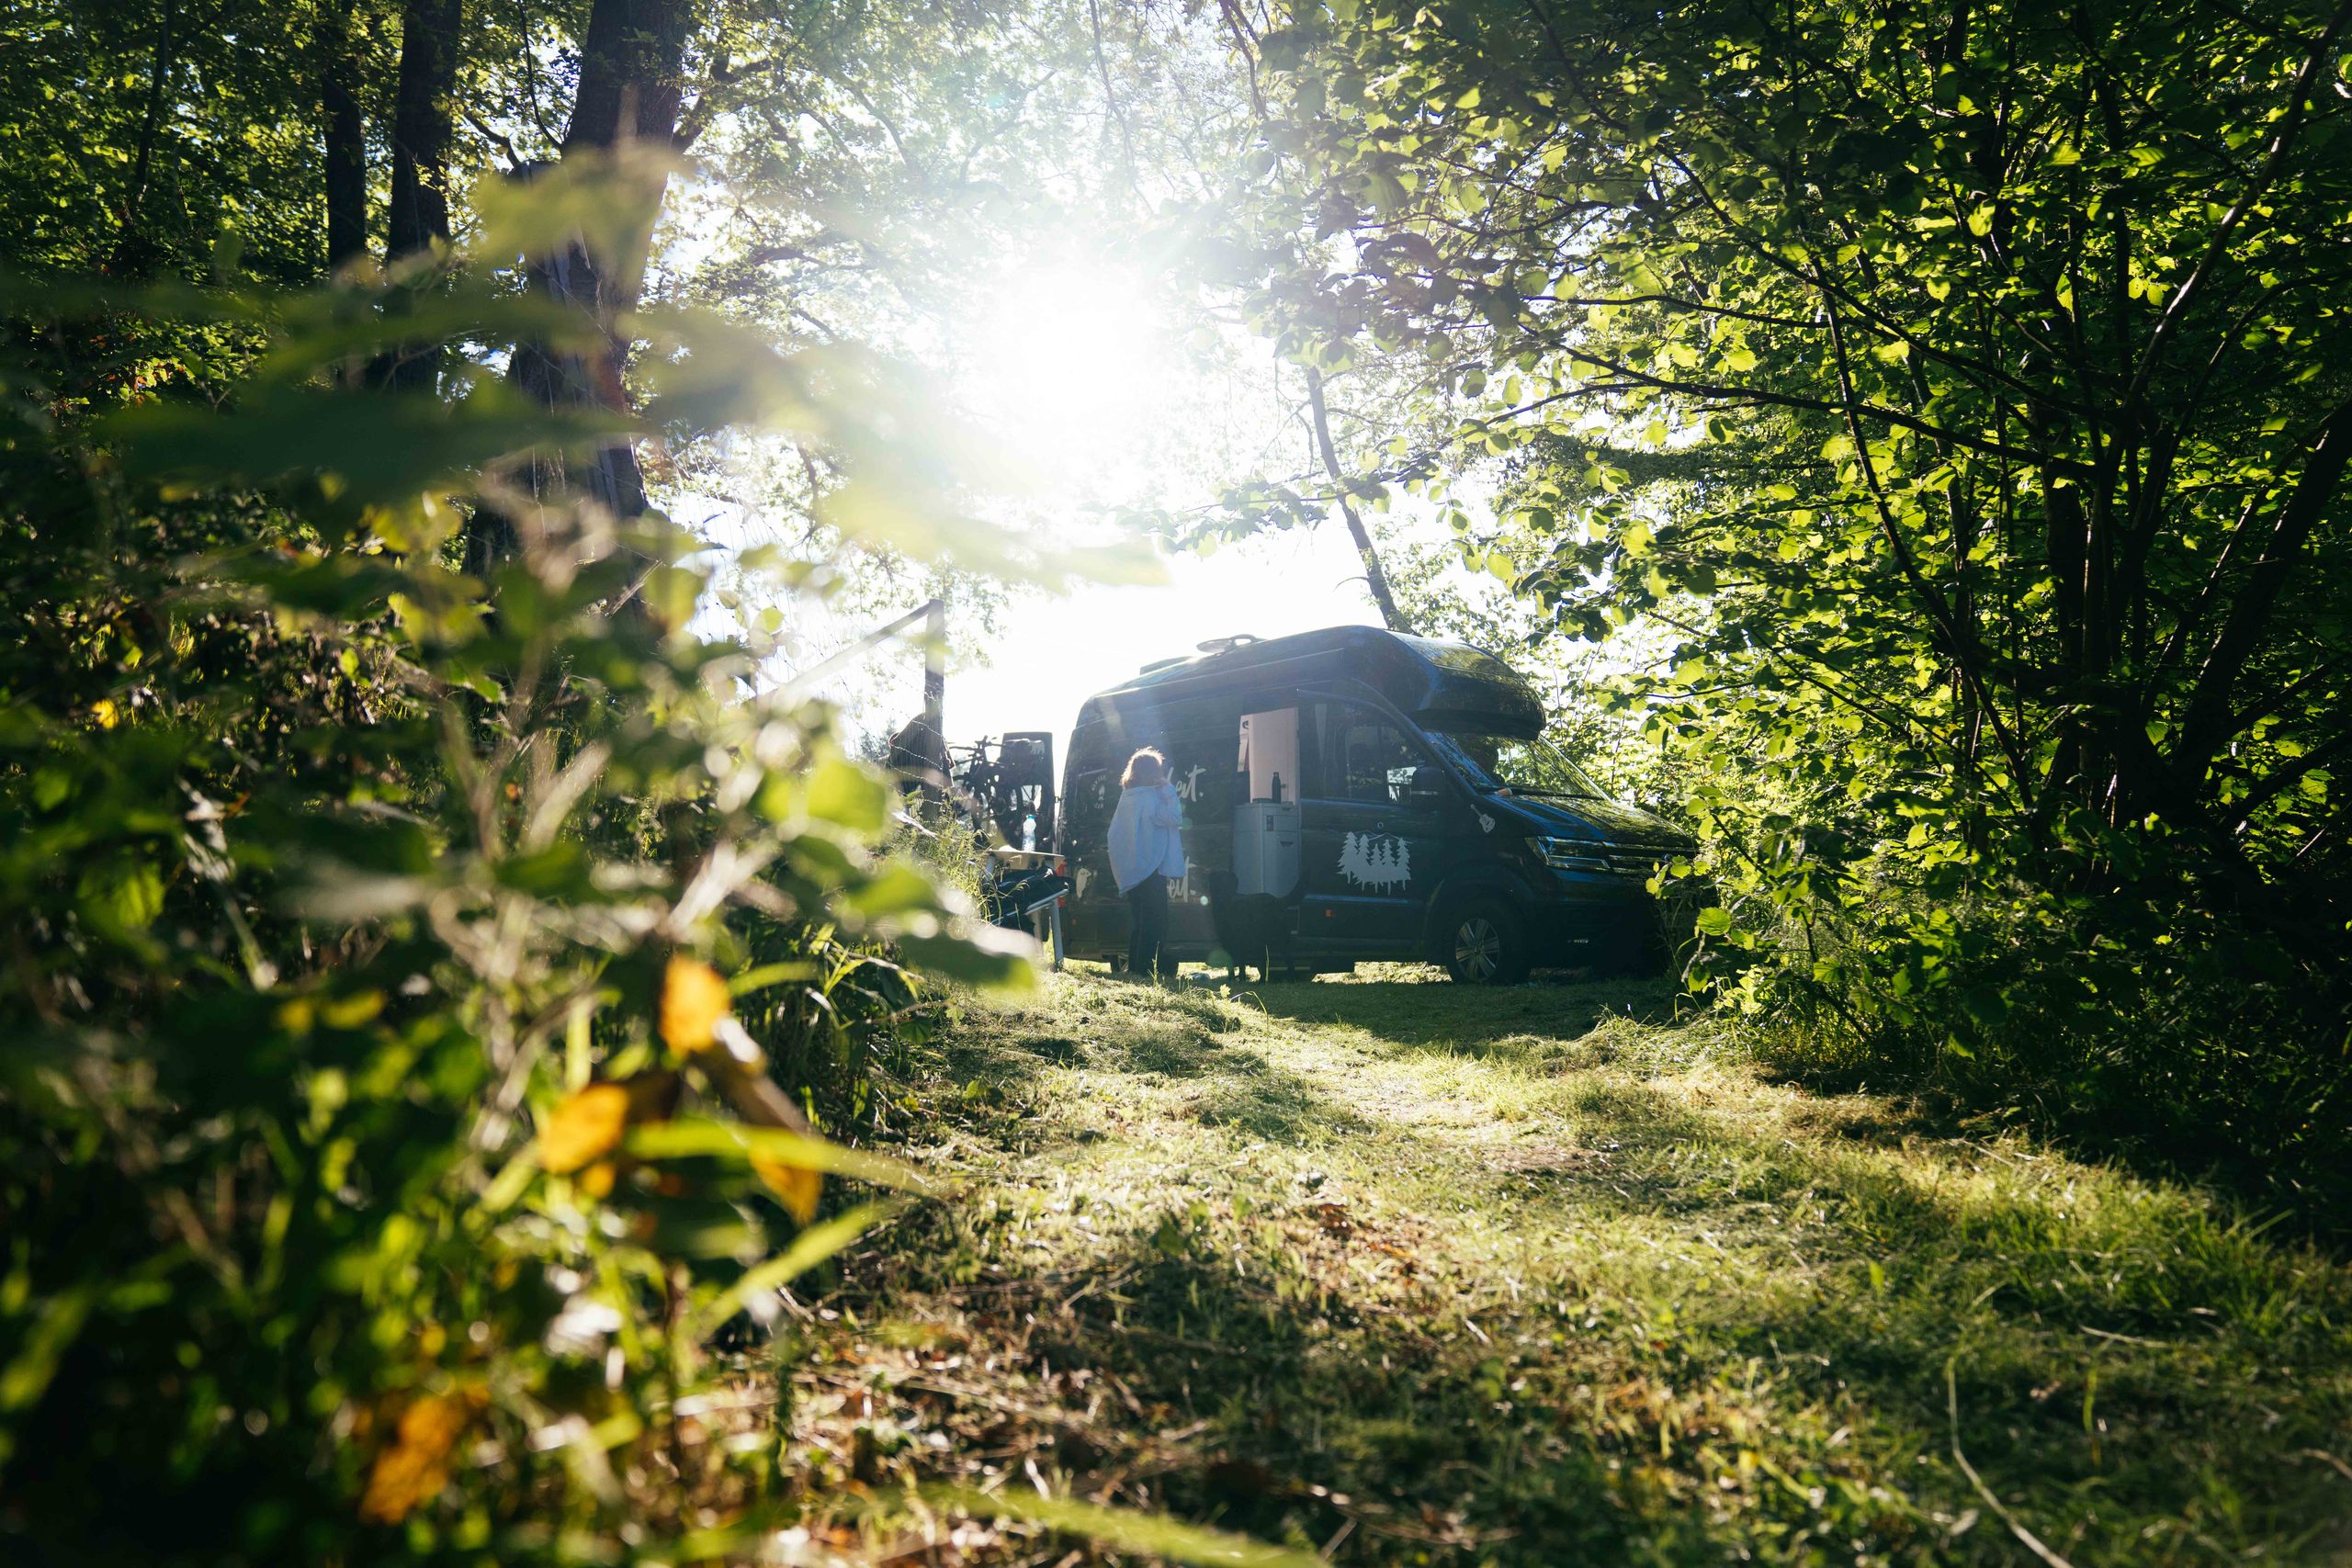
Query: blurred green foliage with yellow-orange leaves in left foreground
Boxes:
[{"xmin": 0, "ymin": 160, "xmax": 1025, "ymax": 1563}]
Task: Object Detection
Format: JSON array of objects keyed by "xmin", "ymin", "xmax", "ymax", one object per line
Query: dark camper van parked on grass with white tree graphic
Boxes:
[{"xmin": 1061, "ymin": 626, "xmax": 1693, "ymax": 983}]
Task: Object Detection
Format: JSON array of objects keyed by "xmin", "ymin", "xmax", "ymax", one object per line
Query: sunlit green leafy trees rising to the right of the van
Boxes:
[{"xmin": 1230, "ymin": 0, "xmax": 2352, "ymax": 1175}]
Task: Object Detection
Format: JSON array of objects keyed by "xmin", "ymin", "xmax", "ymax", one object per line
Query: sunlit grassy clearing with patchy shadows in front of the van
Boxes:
[{"xmin": 786, "ymin": 968, "xmax": 2352, "ymax": 1565}]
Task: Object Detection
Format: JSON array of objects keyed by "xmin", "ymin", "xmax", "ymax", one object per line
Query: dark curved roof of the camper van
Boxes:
[{"xmin": 1089, "ymin": 626, "xmax": 1543, "ymax": 736}]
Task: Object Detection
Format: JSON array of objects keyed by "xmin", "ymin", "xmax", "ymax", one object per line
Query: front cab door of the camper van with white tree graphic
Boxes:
[{"xmin": 1298, "ymin": 701, "xmax": 1444, "ymax": 957}]
